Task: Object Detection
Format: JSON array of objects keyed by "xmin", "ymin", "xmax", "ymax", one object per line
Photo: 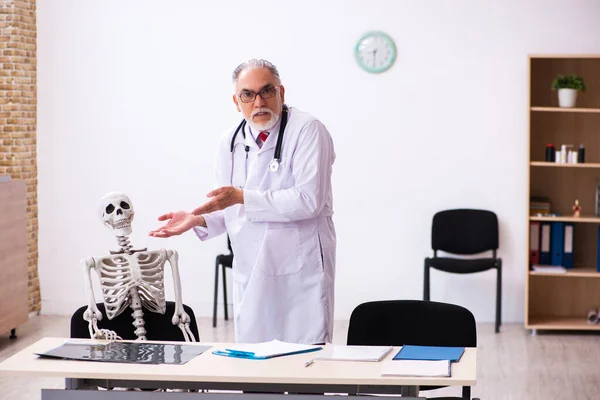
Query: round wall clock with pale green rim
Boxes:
[{"xmin": 354, "ymin": 32, "xmax": 396, "ymax": 73}]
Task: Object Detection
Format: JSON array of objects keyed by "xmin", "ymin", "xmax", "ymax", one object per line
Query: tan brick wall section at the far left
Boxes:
[{"xmin": 0, "ymin": 0, "xmax": 41, "ymax": 312}]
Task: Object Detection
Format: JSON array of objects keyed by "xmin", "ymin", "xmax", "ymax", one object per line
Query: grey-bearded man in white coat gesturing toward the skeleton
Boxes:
[{"xmin": 150, "ymin": 60, "xmax": 336, "ymax": 344}]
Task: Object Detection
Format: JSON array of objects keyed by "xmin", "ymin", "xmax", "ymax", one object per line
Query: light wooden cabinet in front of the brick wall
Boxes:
[{"xmin": 0, "ymin": 180, "xmax": 29, "ymax": 333}]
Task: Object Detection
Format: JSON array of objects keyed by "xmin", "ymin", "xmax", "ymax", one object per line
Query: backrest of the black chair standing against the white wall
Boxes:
[{"xmin": 431, "ymin": 209, "xmax": 498, "ymax": 254}]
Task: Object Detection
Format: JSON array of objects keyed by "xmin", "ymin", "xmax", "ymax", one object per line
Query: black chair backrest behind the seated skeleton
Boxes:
[{"xmin": 71, "ymin": 301, "xmax": 200, "ymax": 342}]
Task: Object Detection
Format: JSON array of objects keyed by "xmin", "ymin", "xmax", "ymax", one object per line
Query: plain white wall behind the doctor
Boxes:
[{"xmin": 38, "ymin": 0, "xmax": 600, "ymax": 322}]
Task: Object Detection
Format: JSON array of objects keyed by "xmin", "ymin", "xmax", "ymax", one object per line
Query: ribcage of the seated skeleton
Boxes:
[{"xmin": 96, "ymin": 251, "xmax": 167, "ymax": 319}]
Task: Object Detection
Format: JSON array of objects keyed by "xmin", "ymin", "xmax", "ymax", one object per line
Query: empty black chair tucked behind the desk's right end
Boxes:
[{"xmin": 347, "ymin": 300, "xmax": 477, "ymax": 400}]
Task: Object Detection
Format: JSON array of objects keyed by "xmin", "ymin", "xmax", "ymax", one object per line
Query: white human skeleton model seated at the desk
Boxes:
[{"xmin": 81, "ymin": 192, "xmax": 196, "ymax": 342}]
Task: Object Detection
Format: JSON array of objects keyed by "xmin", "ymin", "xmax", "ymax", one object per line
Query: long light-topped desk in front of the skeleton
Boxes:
[{"xmin": 0, "ymin": 338, "xmax": 477, "ymax": 400}]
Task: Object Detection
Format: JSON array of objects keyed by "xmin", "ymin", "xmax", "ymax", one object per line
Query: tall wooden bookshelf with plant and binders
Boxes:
[{"xmin": 525, "ymin": 55, "xmax": 600, "ymax": 331}]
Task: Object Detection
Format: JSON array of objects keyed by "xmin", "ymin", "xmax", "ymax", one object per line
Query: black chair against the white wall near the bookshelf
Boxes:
[{"xmin": 423, "ymin": 209, "xmax": 502, "ymax": 333}]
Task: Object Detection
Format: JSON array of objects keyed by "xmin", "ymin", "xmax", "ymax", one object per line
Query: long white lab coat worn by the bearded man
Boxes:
[{"xmin": 194, "ymin": 108, "xmax": 336, "ymax": 344}]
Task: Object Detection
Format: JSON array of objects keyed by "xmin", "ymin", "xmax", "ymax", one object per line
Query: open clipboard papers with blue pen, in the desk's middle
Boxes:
[{"xmin": 213, "ymin": 340, "xmax": 322, "ymax": 360}]
